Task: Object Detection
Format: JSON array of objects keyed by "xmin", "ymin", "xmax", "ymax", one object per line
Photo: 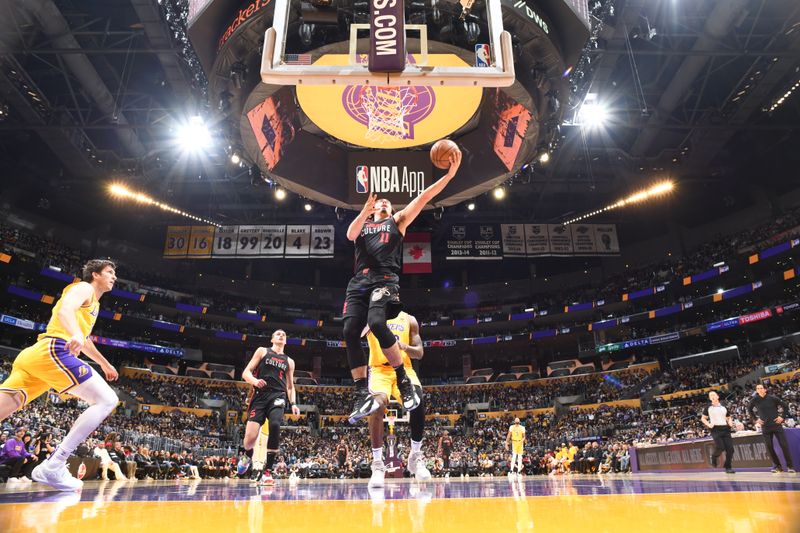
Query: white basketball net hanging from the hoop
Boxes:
[{"xmin": 361, "ymin": 86, "xmax": 418, "ymax": 143}]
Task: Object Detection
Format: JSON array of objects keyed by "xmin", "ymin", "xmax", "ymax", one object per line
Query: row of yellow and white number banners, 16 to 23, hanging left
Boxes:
[{"xmin": 164, "ymin": 224, "xmax": 334, "ymax": 259}]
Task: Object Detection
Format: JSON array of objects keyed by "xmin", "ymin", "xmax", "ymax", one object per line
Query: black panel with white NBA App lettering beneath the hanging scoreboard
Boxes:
[{"xmin": 347, "ymin": 151, "xmax": 433, "ymax": 208}]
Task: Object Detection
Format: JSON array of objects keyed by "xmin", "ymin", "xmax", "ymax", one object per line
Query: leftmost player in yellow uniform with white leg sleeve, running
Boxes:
[{"xmin": 0, "ymin": 259, "xmax": 119, "ymax": 490}]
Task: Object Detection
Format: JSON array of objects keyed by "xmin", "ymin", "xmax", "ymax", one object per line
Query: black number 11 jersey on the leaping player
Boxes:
[{"xmin": 355, "ymin": 217, "xmax": 403, "ymax": 274}]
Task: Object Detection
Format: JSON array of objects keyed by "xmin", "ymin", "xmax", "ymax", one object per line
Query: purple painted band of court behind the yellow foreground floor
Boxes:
[{"xmin": 0, "ymin": 474, "xmax": 800, "ymax": 506}]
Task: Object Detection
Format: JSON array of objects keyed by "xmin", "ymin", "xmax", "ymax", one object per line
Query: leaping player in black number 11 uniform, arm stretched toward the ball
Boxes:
[{"xmin": 342, "ymin": 151, "xmax": 461, "ymax": 424}]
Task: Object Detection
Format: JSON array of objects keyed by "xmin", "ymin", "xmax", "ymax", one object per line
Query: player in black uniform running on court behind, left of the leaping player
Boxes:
[{"xmin": 242, "ymin": 329, "xmax": 300, "ymax": 485}]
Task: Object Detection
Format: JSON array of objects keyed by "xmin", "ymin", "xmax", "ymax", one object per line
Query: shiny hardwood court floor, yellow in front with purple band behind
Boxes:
[{"xmin": 0, "ymin": 473, "xmax": 800, "ymax": 533}]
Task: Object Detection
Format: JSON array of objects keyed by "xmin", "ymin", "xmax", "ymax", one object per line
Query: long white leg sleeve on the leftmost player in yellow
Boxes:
[{"xmin": 48, "ymin": 375, "xmax": 119, "ymax": 468}]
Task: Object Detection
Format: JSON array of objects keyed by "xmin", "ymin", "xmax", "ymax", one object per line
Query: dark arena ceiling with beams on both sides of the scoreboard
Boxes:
[{"xmin": 0, "ymin": 0, "xmax": 800, "ymax": 237}]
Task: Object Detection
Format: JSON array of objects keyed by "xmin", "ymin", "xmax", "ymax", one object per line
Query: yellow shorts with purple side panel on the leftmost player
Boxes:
[{"xmin": 0, "ymin": 337, "xmax": 92, "ymax": 405}]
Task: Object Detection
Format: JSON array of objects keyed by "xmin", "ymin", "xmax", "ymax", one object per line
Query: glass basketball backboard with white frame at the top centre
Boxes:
[{"xmin": 261, "ymin": 0, "xmax": 515, "ymax": 87}]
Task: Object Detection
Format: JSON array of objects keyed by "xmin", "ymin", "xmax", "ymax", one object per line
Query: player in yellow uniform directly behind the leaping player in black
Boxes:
[{"xmin": 367, "ymin": 312, "xmax": 431, "ymax": 487}]
